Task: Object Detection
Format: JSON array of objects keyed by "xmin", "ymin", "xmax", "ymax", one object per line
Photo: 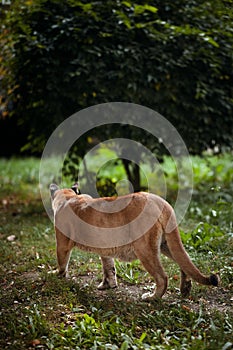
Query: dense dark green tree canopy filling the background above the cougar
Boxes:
[{"xmin": 0, "ymin": 0, "xmax": 233, "ymax": 158}]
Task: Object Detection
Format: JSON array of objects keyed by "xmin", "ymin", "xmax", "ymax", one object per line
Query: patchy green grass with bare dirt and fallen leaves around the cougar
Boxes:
[{"xmin": 0, "ymin": 155, "xmax": 233, "ymax": 350}]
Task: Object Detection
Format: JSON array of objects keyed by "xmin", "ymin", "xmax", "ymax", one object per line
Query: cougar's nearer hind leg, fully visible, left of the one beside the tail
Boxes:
[{"xmin": 135, "ymin": 242, "xmax": 168, "ymax": 300}]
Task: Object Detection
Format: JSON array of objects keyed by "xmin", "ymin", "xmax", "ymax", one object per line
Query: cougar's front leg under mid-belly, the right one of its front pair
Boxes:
[{"xmin": 98, "ymin": 256, "xmax": 117, "ymax": 289}]
